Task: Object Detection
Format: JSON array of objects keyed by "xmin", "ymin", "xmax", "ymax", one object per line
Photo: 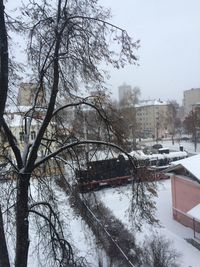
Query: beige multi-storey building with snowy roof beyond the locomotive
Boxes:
[{"xmin": 135, "ymin": 100, "xmax": 173, "ymax": 138}]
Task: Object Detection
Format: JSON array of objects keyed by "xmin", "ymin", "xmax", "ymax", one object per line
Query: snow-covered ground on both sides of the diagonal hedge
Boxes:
[{"xmin": 28, "ymin": 180, "xmax": 200, "ymax": 267}]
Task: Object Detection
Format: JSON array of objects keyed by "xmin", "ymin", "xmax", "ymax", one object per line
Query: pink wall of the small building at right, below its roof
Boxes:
[{"xmin": 171, "ymin": 175, "xmax": 200, "ymax": 232}]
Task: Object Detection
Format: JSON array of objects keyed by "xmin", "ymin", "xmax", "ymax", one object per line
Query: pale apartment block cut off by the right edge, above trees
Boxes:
[{"xmin": 183, "ymin": 88, "xmax": 200, "ymax": 116}]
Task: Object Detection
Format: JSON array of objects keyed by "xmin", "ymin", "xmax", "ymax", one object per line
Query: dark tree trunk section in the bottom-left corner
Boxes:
[{"xmin": 0, "ymin": 206, "xmax": 10, "ymax": 267}]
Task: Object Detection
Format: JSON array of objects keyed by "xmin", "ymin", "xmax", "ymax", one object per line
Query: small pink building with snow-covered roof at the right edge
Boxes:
[{"xmin": 167, "ymin": 155, "xmax": 200, "ymax": 232}]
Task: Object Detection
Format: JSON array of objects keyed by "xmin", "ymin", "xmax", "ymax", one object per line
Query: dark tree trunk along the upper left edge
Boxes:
[{"xmin": 0, "ymin": 0, "xmax": 8, "ymax": 123}]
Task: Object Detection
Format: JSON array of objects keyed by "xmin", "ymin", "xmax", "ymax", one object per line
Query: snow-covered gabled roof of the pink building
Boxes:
[{"xmin": 167, "ymin": 154, "xmax": 200, "ymax": 181}]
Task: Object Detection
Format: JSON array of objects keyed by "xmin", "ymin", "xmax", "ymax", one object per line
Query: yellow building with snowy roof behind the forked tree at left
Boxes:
[{"xmin": 0, "ymin": 106, "xmax": 64, "ymax": 179}]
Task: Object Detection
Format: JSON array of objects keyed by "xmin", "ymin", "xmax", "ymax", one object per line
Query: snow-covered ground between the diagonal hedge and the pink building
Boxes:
[{"xmin": 99, "ymin": 180, "xmax": 200, "ymax": 267}]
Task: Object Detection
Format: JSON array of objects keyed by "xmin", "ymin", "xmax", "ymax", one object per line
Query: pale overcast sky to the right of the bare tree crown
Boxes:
[{"xmin": 101, "ymin": 0, "xmax": 200, "ymax": 104}]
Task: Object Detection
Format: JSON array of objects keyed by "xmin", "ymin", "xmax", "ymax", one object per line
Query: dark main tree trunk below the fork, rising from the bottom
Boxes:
[{"xmin": 15, "ymin": 174, "xmax": 30, "ymax": 267}]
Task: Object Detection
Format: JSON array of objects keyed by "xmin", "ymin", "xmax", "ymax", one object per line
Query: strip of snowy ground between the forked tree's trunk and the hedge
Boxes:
[{"xmin": 28, "ymin": 183, "xmax": 100, "ymax": 267}]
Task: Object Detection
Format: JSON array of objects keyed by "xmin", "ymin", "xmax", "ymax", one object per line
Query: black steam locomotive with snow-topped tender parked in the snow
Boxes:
[{"xmin": 76, "ymin": 151, "xmax": 187, "ymax": 193}]
